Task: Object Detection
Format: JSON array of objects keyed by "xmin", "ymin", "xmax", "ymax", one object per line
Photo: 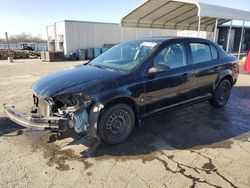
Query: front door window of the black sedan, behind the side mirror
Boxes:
[{"xmin": 154, "ymin": 43, "xmax": 187, "ymax": 69}]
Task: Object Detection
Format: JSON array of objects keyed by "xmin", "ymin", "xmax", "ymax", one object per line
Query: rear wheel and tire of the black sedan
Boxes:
[{"xmin": 209, "ymin": 79, "xmax": 232, "ymax": 108}]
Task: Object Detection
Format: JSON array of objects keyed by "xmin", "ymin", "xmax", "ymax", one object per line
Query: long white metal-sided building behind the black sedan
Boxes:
[{"xmin": 47, "ymin": 20, "xmax": 177, "ymax": 57}]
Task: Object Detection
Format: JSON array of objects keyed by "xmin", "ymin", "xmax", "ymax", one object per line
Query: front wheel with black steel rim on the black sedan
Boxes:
[{"xmin": 98, "ymin": 104, "xmax": 135, "ymax": 145}]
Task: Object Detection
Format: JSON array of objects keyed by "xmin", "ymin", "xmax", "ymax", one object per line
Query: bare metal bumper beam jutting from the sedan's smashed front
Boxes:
[{"xmin": 3, "ymin": 104, "xmax": 68, "ymax": 131}]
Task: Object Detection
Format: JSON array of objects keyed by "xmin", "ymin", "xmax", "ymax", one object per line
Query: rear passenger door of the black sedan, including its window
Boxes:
[{"xmin": 188, "ymin": 39, "xmax": 219, "ymax": 99}]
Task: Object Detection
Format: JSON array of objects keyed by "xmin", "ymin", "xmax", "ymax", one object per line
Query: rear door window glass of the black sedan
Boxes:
[{"xmin": 190, "ymin": 43, "xmax": 212, "ymax": 64}]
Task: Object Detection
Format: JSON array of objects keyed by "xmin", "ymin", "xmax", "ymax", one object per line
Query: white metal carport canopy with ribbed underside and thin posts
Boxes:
[{"xmin": 121, "ymin": 0, "xmax": 250, "ymax": 58}]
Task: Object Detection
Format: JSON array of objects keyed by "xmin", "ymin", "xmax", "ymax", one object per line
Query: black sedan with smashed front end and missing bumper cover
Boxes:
[{"xmin": 4, "ymin": 38, "xmax": 239, "ymax": 145}]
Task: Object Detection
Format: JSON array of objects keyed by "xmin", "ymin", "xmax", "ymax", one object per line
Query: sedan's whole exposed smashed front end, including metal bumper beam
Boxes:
[{"xmin": 4, "ymin": 93, "xmax": 103, "ymax": 137}]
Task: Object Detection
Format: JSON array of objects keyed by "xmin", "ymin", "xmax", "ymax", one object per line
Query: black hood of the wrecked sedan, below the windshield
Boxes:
[{"xmin": 32, "ymin": 65, "xmax": 122, "ymax": 97}]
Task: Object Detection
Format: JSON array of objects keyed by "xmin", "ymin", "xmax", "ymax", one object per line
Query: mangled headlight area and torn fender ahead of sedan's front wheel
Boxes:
[{"xmin": 51, "ymin": 93, "xmax": 104, "ymax": 137}]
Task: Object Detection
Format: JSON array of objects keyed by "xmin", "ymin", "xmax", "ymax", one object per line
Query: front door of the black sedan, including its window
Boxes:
[{"xmin": 143, "ymin": 43, "xmax": 193, "ymax": 115}]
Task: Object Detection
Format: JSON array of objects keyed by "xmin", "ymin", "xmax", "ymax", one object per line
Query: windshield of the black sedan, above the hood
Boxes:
[{"xmin": 90, "ymin": 41, "xmax": 158, "ymax": 71}]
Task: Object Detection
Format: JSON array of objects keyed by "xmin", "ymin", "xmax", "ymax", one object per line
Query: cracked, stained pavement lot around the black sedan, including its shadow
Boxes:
[{"xmin": 0, "ymin": 60, "xmax": 250, "ymax": 188}]
